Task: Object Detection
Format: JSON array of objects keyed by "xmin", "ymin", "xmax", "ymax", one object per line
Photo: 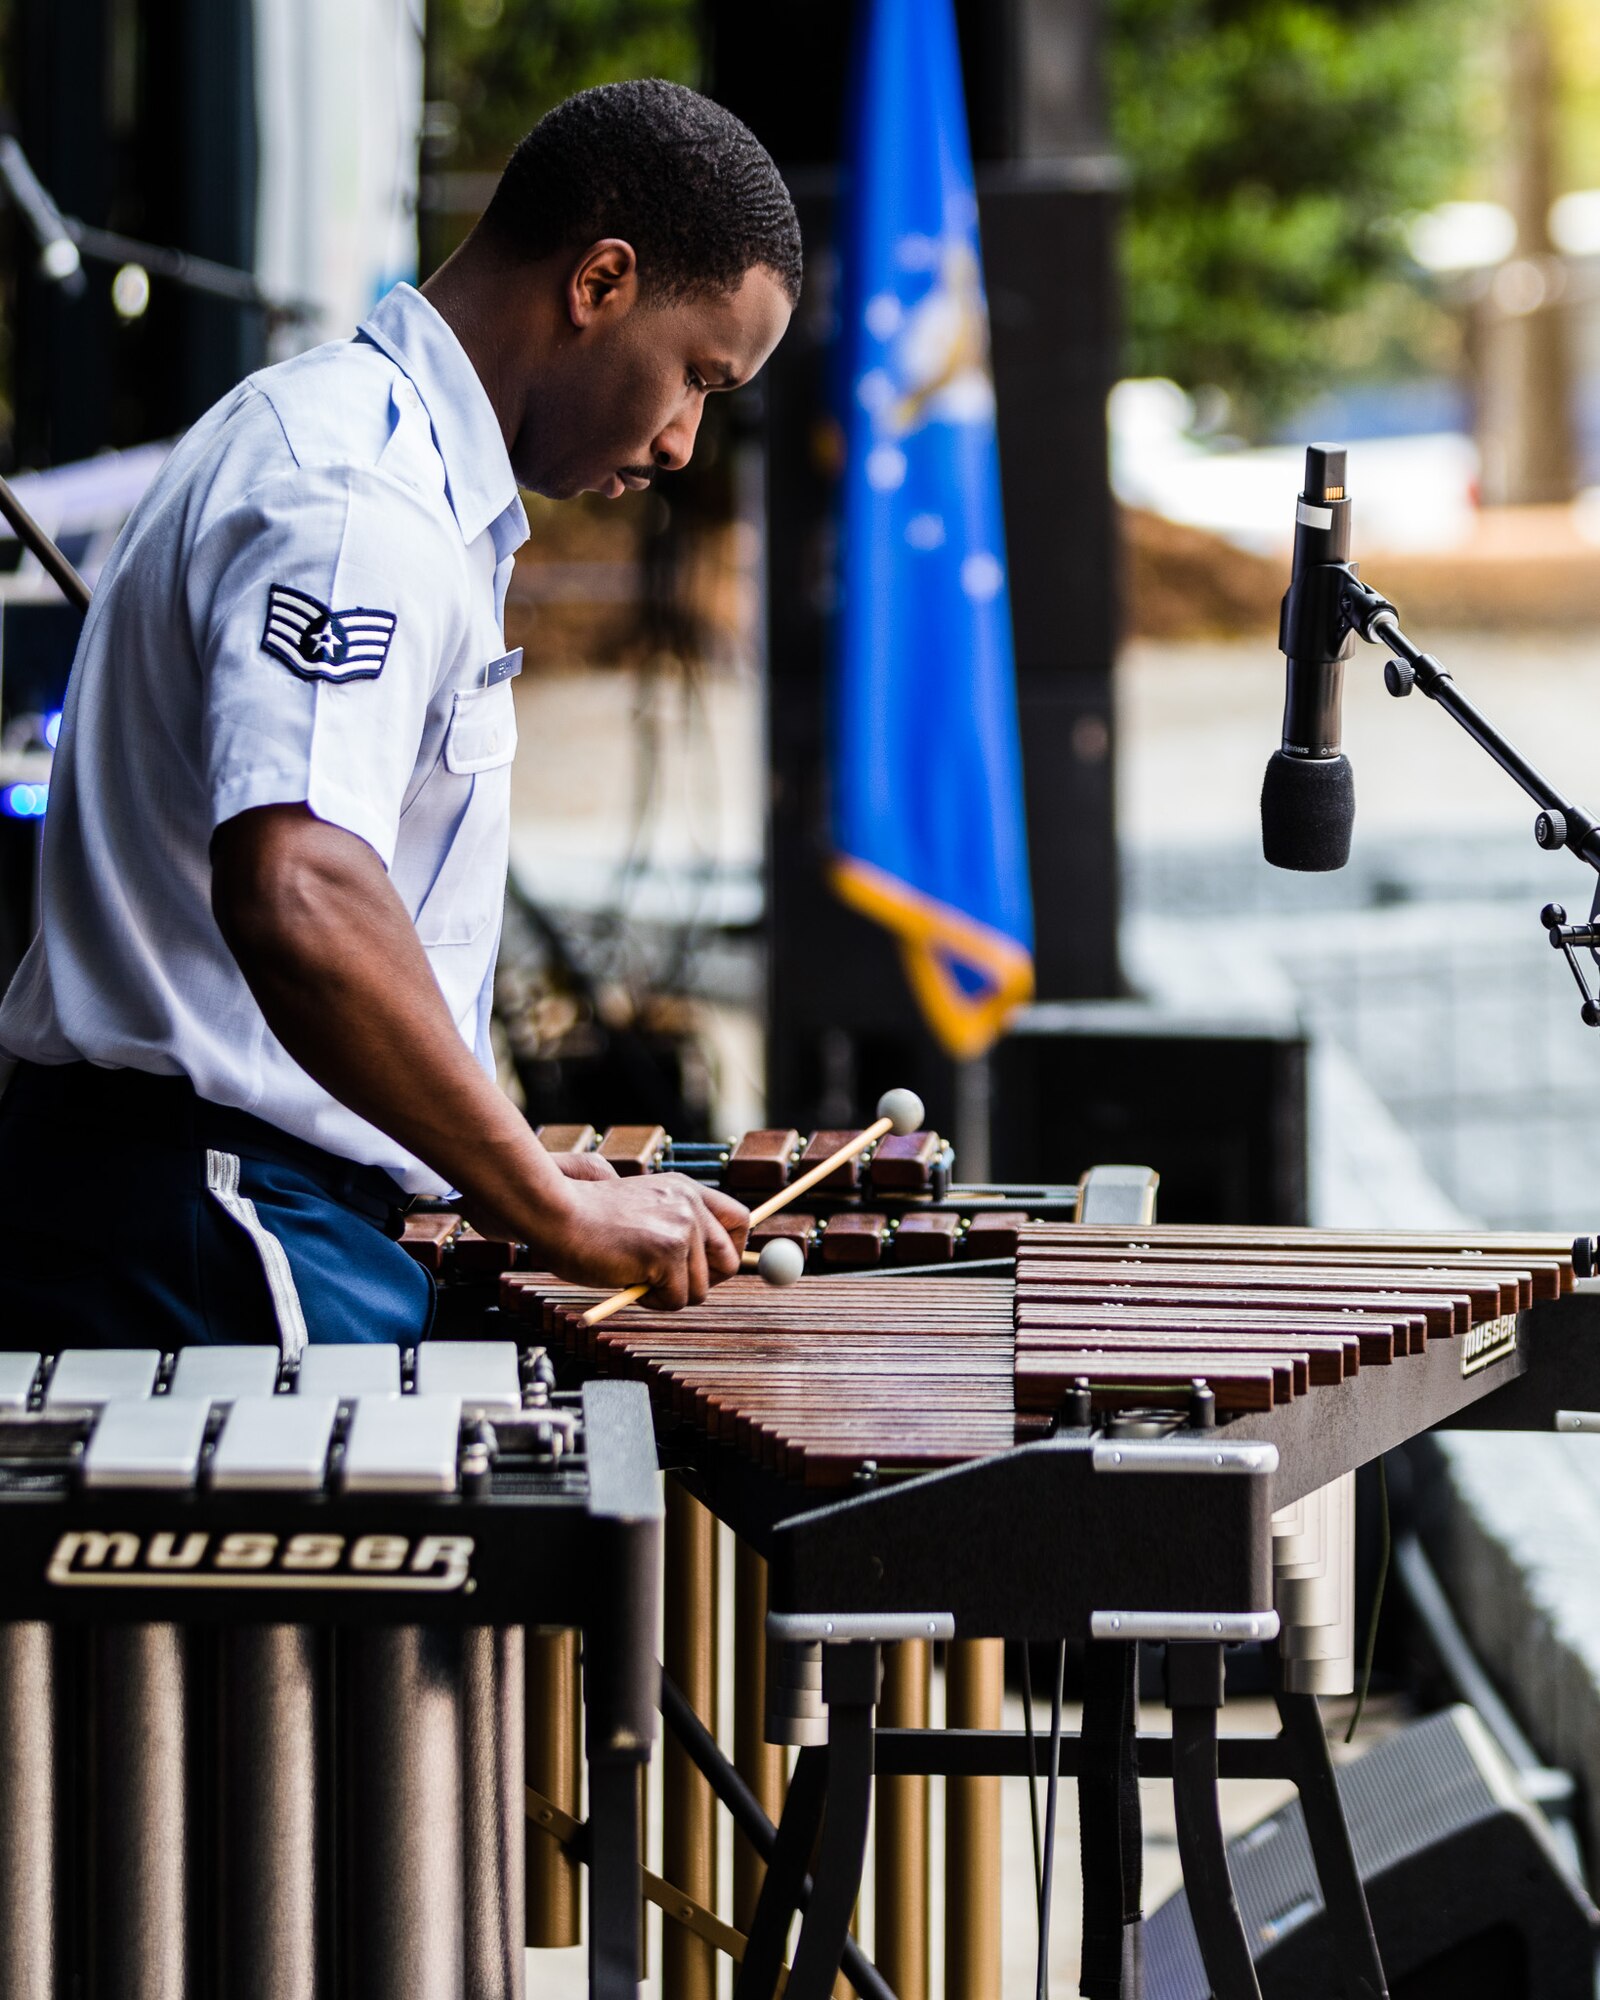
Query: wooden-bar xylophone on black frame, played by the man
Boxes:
[{"xmin": 460, "ymin": 1144, "xmax": 1600, "ymax": 2000}]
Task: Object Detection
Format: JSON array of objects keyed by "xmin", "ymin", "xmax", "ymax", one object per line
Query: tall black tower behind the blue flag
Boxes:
[{"xmin": 708, "ymin": 0, "xmax": 1118, "ymax": 1130}]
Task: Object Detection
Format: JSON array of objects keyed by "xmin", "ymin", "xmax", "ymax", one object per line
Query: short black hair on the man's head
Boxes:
[{"xmin": 482, "ymin": 78, "xmax": 800, "ymax": 304}]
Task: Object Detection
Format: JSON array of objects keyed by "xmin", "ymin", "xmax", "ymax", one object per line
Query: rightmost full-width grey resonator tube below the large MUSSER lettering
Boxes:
[{"xmin": 340, "ymin": 1626, "xmax": 464, "ymax": 2000}]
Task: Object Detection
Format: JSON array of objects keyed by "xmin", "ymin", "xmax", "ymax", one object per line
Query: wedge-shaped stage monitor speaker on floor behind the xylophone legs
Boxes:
[{"xmin": 1144, "ymin": 1706, "xmax": 1600, "ymax": 2000}]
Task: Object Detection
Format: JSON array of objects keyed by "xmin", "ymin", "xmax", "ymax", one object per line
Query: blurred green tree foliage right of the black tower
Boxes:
[{"xmin": 1108, "ymin": 0, "xmax": 1492, "ymax": 430}]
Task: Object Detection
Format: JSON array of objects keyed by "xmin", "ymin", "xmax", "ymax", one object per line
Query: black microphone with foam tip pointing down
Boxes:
[{"xmin": 1262, "ymin": 444, "xmax": 1356, "ymax": 874}]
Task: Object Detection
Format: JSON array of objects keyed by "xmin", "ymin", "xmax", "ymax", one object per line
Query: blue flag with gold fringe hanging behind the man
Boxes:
[{"xmin": 832, "ymin": 0, "xmax": 1034, "ymax": 1058}]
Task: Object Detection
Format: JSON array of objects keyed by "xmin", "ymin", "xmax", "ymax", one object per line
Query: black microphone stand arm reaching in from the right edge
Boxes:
[{"xmin": 1330, "ymin": 564, "xmax": 1600, "ymax": 1028}]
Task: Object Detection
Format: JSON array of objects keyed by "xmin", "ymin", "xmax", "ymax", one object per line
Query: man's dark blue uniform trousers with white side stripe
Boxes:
[{"xmin": 0, "ymin": 1062, "xmax": 434, "ymax": 1354}]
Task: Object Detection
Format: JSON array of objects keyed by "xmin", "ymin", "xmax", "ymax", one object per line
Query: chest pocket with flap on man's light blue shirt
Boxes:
[{"xmin": 416, "ymin": 682, "xmax": 516, "ymax": 946}]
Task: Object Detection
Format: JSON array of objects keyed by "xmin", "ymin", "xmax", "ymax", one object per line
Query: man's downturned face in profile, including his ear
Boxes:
[{"xmin": 512, "ymin": 246, "xmax": 790, "ymax": 500}]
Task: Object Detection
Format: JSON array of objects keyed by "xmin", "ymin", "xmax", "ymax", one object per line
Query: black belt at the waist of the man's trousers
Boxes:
[{"xmin": 4, "ymin": 1062, "xmax": 412, "ymax": 1236}]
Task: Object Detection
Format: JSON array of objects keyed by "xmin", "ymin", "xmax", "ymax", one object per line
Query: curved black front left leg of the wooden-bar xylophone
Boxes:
[{"xmin": 786, "ymin": 1642, "xmax": 880, "ymax": 2000}]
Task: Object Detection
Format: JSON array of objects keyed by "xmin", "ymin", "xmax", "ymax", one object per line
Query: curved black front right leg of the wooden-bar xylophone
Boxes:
[{"xmin": 1166, "ymin": 1644, "xmax": 1262, "ymax": 2000}]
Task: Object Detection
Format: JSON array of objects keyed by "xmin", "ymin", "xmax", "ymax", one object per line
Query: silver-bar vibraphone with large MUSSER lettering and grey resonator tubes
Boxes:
[{"xmin": 0, "ymin": 1342, "xmax": 660, "ymax": 2000}]
